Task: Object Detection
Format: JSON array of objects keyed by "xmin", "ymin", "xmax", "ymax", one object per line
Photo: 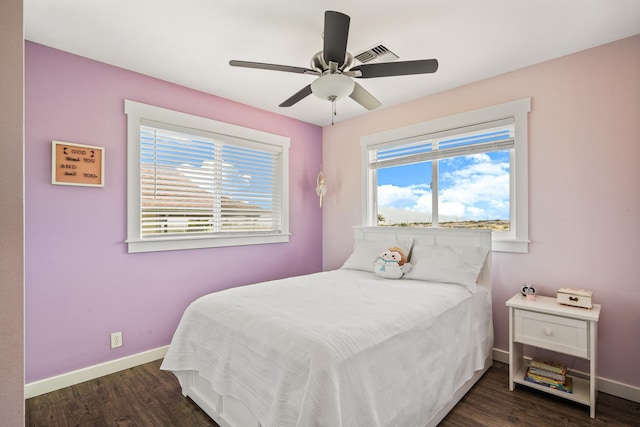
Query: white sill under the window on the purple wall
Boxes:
[{"xmin": 126, "ymin": 233, "xmax": 289, "ymax": 254}]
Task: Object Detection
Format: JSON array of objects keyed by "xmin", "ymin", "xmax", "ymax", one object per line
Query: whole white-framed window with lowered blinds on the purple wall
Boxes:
[{"xmin": 125, "ymin": 100, "xmax": 289, "ymax": 252}]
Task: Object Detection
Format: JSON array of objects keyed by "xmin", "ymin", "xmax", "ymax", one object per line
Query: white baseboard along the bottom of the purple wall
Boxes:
[{"xmin": 24, "ymin": 346, "xmax": 169, "ymax": 399}]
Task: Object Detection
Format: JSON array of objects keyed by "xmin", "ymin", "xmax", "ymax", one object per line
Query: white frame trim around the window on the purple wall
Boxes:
[{"xmin": 124, "ymin": 99, "xmax": 290, "ymax": 253}]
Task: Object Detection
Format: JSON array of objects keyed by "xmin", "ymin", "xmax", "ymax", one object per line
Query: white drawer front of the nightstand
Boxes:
[{"xmin": 513, "ymin": 309, "xmax": 590, "ymax": 359}]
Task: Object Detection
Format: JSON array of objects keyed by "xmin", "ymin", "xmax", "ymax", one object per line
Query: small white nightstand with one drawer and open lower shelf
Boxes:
[{"xmin": 506, "ymin": 294, "xmax": 600, "ymax": 418}]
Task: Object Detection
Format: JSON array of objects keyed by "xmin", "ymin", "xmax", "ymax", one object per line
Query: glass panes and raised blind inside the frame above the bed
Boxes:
[{"xmin": 369, "ymin": 118, "xmax": 514, "ymax": 231}]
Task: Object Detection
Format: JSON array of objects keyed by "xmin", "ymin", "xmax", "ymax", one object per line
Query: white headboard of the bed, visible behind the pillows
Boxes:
[{"xmin": 354, "ymin": 227, "xmax": 491, "ymax": 290}]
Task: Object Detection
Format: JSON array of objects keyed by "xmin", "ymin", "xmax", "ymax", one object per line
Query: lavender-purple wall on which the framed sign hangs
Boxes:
[{"xmin": 25, "ymin": 42, "xmax": 322, "ymax": 383}]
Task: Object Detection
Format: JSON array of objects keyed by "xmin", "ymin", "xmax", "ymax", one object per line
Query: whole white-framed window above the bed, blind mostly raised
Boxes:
[{"xmin": 361, "ymin": 98, "xmax": 531, "ymax": 253}]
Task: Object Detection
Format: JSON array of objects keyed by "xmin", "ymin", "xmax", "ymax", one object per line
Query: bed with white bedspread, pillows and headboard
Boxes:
[{"xmin": 161, "ymin": 227, "xmax": 493, "ymax": 427}]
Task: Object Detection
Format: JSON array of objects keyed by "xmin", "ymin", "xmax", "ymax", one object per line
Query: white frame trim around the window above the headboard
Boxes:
[{"xmin": 360, "ymin": 98, "xmax": 531, "ymax": 253}]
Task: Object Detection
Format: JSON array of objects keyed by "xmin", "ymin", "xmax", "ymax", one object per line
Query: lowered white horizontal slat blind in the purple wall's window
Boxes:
[{"xmin": 140, "ymin": 122, "xmax": 282, "ymax": 238}]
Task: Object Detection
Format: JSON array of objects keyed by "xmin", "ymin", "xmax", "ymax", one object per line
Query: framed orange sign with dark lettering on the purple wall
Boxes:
[{"xmin": 51, "ymin": 141, "xmax": 104, "ymax": 187}]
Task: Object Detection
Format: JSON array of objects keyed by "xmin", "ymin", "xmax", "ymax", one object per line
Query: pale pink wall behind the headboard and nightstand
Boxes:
[{"xmin": 323, "ymin": 36, "xmax": 640, "ymax": 387}]
